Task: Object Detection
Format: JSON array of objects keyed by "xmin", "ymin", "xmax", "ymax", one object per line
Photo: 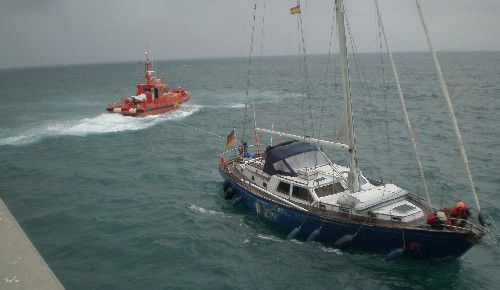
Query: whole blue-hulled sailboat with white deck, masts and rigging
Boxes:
[{"xmin": 219, "ymin": 0, "xmax": 496, "ymax": 260}]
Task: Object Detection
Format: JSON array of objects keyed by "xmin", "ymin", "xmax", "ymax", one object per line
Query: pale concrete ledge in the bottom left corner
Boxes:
[{"xmin": 0, "ymin": 199, "xmax": 64, "ymax": 289}]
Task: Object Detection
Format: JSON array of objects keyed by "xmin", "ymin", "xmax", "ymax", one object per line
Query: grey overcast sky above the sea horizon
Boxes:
[{"xmin": 0, "ymin": 0, "xmax": 500, "ymax": 68}]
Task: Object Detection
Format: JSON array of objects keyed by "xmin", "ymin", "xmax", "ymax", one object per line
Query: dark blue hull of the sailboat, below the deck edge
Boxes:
[{"xmin": 220, "ymin": 170, "xmax": 475, "ymax": 260}]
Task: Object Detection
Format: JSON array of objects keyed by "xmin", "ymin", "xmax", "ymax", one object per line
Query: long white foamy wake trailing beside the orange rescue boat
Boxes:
[{"xmin": 0, "ymin": 104, "xmax": 202, "ymax": 146}]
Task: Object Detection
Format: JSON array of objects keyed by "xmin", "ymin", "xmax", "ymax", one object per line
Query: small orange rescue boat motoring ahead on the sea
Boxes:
[{"xmin": 106, "ymin": 52, "xmax": 191, "ymax": 117}]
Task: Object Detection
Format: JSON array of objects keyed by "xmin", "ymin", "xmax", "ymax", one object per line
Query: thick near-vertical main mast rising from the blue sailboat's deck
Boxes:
[{"xmin": 335, "ymin": 0, "xmax": 360, "ymax": 193}]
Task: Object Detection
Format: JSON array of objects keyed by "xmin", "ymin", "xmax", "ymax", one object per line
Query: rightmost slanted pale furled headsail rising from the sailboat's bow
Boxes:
[{"xmin": 415, "ymin": 0, "xmax": 484, "ymax": 225}]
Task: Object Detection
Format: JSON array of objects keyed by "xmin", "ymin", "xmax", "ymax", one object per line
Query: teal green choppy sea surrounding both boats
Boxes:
[{"xmin": 0, "ymin": 52, "xmax": 500, "ymax": 289}]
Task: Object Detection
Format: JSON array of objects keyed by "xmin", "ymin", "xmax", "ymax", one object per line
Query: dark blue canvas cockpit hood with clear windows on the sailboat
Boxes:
[{"xmin": 264, "ymin": 141, "xmax": 328, "ymax": 176}]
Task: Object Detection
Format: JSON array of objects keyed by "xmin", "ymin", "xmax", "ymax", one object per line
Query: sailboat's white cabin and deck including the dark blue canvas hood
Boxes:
[{"xmin": 235, "ymin": 141, "xmax": 424, "ymax": 222}]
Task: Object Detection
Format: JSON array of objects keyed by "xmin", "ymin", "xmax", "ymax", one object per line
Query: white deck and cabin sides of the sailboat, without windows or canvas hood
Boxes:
[{"xmin": 238, "ymin": 158, "xmax": 424, "ymax": 222}]
